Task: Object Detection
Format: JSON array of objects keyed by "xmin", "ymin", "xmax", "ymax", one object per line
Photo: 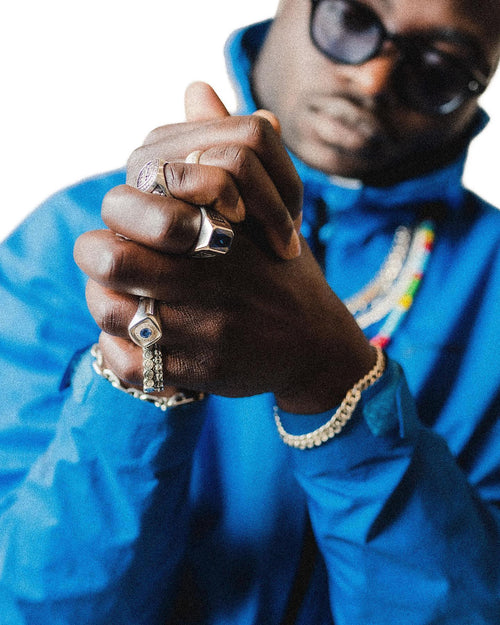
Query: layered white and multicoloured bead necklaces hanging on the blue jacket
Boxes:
[{"xmin": 346, "ymin": 220, "xmax": 435, "ymax": 349}]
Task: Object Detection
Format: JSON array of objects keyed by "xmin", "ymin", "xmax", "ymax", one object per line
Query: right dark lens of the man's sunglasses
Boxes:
[{"xmin": 395, "ymin": 49, "xmax": 469, "ymax": 114}]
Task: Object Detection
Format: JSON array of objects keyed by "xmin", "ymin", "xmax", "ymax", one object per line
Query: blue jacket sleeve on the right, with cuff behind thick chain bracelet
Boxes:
[{"xmin": 281, "ymin": 361, "xmax": 500, "ymax": 625}]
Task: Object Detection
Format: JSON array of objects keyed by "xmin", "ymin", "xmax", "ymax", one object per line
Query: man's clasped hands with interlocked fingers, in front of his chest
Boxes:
[{"xmin": 75, "ymin": 83, "xmax": 374, "ymax": 413}]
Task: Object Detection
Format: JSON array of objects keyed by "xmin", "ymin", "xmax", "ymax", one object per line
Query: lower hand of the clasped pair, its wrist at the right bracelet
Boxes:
[{"xmin": 75, "ymin": 228, "xmax": 374, "ymax": 412}]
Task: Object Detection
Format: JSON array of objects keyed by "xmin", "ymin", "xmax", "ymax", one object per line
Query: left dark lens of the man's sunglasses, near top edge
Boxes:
[{"xmin": 311, "ymin": 0, "xmax": 383, "ymax": 65}]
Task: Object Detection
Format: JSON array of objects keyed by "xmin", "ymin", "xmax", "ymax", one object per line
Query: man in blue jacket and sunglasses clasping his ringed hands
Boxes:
[{"xmin": 1, "ymin": 0, "xmax": 500, "ymax": 625}]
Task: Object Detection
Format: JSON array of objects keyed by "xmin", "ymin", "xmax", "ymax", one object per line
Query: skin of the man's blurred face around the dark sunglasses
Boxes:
[{"xmin": 253, "ymin": 0, "xmax": 500, "ymax": 186}]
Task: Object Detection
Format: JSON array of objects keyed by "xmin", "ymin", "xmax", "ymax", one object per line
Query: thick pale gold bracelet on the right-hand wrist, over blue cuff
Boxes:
[{"xmin": 273, "ymin": 347, "xmax": 385, "ymax": 449}]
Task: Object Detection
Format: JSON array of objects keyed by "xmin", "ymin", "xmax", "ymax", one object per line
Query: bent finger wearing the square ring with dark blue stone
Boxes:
[{"xmin": 101, "ymin": 185, "xmax": 201, "ymax": 254}]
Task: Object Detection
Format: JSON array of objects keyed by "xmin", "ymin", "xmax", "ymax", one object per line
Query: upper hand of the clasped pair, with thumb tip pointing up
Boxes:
[{"xmin": 114, "ymin": 83, "xmax": 302, "ymax": 259}]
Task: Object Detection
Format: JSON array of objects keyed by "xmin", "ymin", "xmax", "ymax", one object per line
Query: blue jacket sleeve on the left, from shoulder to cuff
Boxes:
[{"xmin": 0, "ymin": 178, "xmax": 202, "ymax": 625}]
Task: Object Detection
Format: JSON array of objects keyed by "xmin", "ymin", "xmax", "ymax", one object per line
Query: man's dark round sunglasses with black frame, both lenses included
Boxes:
[{"xmin": 310, "ymin": 0, "xmax": 488, "ymax": 115}]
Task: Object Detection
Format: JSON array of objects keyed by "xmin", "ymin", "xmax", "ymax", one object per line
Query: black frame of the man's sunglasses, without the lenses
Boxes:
[{"xmin": 309, "ymin": 0, "xmax": 488, "ymax": 115}]
